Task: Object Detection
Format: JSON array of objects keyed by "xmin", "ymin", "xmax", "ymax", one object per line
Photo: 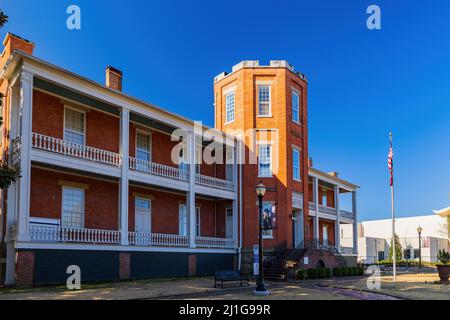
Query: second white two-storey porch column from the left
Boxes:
[{"xmin": 119, "ymin": 109, "xmax": 130, "ymax": 246}]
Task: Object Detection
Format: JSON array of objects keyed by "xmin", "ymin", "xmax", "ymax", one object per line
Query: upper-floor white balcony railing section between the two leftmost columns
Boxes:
[{"xmin": 32, "ymin": 132, "xmax": 121, "ymax": 166}]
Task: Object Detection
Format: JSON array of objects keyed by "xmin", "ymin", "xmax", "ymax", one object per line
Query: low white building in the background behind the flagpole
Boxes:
[{"xmin": 341, "ymin": 210, "xmax": 449, "ymax": 263}]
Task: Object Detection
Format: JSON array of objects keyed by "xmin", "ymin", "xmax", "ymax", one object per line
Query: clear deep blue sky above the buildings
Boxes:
[{"xmin": 0, "ymin": 0, "xmax": 450, "ymax": 220}]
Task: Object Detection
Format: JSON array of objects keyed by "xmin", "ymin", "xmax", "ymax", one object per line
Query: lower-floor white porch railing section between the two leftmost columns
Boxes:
[{"xmin": 29, "ymin": 224, "xmax": 120, "ymax": 244}]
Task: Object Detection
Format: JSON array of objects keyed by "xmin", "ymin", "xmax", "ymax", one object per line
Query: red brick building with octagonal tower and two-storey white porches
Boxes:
[{"xmin": 0, "ymin": 34, "xmax": 357, "ymax": 284}]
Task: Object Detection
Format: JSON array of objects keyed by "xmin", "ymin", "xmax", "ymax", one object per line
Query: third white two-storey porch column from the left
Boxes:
[{"xmin": 187, "ymin": 132, "xmax": 197, "ymax": 248}]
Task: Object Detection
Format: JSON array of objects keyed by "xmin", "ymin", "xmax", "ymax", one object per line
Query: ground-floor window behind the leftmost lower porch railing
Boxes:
[{"xmin": 61, "ymin": 187, "xmax": 84, "ymax": 229}]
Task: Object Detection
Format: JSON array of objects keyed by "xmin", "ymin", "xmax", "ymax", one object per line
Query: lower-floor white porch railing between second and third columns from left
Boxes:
[{"xmin": 128, "ymin": 232, "xmax": 189, "ymax": 247}]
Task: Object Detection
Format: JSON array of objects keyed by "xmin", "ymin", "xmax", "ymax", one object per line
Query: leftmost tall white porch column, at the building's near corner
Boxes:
[{"xmin": 17, "ymin": 70, "xmax": 33, "ymax": 241}]
